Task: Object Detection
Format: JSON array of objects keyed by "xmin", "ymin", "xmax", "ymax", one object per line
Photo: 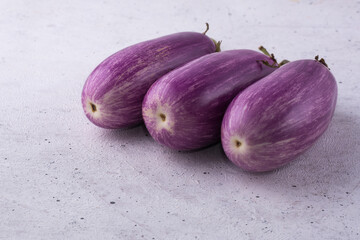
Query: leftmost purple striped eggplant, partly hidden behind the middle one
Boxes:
[{"xmin": 81, "ymin": 32, "xmax": 216, "ymax": 129}]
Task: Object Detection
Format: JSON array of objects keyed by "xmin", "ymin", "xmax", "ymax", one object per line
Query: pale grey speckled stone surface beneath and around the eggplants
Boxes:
[{"xmin": 0, "ymin": 0, "xmax": 360, "ymax": 239}]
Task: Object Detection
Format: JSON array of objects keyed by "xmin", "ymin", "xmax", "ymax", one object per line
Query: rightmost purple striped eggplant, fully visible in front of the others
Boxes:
[{"xmin": 221, "ymin": 60, "xmax": 337, "ymax": 172}]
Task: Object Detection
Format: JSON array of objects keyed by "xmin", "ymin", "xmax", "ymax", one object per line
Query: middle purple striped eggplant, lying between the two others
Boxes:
[{"xmin": 143, "ymin": 50, "xmax": 275, "ymax": 150}]
